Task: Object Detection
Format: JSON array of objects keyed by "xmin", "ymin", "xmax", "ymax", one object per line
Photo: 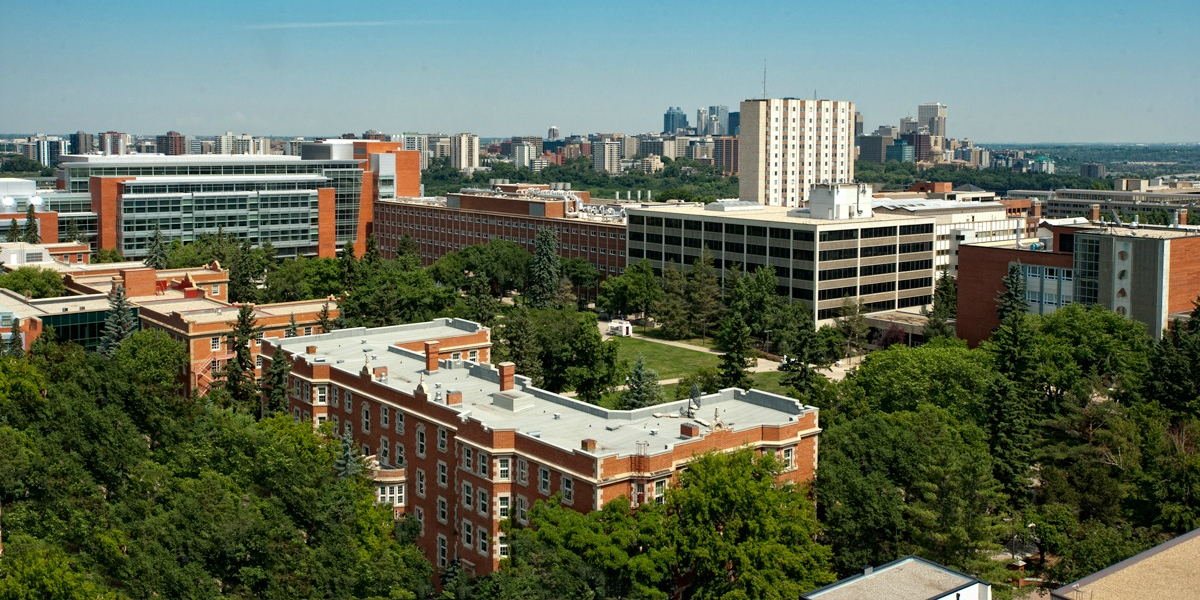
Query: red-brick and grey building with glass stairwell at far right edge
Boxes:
[{"xmin": 958, "ymin": 218, "xmax": 1200, "ymax": 346}]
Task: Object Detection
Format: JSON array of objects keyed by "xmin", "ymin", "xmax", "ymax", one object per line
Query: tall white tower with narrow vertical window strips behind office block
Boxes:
[{"xmin": 738, "ymin": 98, "xmax": 854, "ymax": 206}]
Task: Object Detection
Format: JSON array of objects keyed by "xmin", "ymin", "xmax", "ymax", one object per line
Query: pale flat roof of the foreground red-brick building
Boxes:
[{"xmin": 271, "ymin": 319, "xmax": 816, "ymax": 456}]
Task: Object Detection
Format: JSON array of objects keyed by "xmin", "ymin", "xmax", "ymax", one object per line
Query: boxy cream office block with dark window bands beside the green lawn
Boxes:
[{"xmin": 625, "ymin": 184, "xmax": 936, "ymax": 322}]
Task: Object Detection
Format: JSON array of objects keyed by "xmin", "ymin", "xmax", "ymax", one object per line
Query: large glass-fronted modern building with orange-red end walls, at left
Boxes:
[{"xmin": 37, "ymin": 140, "xmax": 420, "ymax": 258}]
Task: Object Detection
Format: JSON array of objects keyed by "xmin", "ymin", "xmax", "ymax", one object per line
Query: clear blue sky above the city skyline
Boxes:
[{"xmin": 0, "ymin": 0, "xmax": 1200, "ymax": 143}]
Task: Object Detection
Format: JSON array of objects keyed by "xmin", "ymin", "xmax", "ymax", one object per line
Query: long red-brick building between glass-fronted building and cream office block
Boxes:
[{"xmin": 373, "ymin": 184, "xmax": 625, "ymax": 276}]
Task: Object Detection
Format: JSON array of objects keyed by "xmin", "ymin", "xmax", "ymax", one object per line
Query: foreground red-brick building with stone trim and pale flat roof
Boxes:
[{"xmin": 264, "ymin": 319, "xmax": 821, "ymax": 575}]
